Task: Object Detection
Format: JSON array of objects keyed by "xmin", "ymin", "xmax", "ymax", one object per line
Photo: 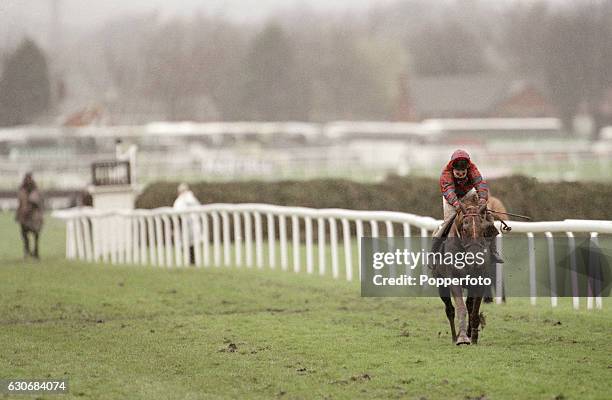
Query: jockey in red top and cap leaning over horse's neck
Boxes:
[{"xmin": 434, "ymin": 150, "xmax": 504, "ymax": 263}]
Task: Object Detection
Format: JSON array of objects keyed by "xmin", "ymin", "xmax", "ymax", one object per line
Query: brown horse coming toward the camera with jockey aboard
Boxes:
[{"xmin": 432, "ymin": 196, "xmax": 491, "ymax": 345}]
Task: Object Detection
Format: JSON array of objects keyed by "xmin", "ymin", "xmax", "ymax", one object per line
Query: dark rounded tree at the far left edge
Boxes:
[{"xmin": 0, "ymin": 39, "xmax": 51, "ymax": 125}]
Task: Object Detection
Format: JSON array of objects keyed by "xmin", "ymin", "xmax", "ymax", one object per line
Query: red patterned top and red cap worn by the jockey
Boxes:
[{"xmin": 440, "ymin": 150, "xmax": 489, "ymax": 207}]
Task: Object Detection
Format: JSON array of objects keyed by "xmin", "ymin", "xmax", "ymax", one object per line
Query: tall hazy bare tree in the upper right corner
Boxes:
[{"xmin": 503, "ymin": 1, "xmax": 612, "ymax": 135}]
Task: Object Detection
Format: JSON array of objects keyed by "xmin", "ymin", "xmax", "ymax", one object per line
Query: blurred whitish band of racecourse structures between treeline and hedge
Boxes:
[{"xmin": 0, "ymin": 118, "xmax": 612, "ymax": 194}]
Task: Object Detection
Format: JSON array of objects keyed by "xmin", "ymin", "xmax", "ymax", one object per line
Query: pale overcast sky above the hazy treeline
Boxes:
[{"xmin": 0, "ymin": 0, "xmax": 397, "ymax": 49}]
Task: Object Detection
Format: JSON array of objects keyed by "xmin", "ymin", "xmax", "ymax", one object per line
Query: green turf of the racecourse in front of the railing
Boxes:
[{"xmin": 0, "ymin": 214, "xmax": 612, "ymax": 399}]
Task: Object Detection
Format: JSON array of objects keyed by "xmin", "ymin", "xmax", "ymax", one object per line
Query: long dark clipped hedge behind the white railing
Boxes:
[{"xmin": 136, "ymin": 176, "xmax": 612, "ymax": 221}]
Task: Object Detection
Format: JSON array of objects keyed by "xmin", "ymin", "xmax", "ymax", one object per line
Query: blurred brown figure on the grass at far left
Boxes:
[{"xmin": 15, "ymin": 173, "xmax": 43, "ymax": 259}]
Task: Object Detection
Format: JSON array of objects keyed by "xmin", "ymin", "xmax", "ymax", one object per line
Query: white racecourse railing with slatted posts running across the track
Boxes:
[{"xmin": 53, "ymin": 204, "xmax": 612, "ymax": 309}]
